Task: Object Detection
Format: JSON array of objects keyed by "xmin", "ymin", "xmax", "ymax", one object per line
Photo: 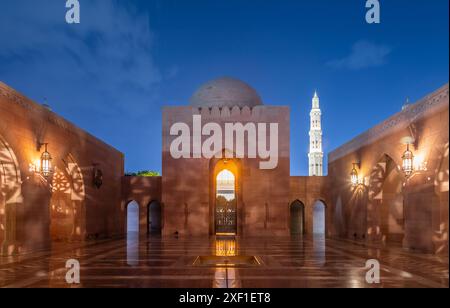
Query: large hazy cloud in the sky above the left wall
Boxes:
[{"xmin": 0, "ymin": 0, "xmax": 164, "ymax": 117}]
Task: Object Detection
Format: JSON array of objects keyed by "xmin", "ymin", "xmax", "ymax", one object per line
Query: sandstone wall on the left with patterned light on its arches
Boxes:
[{"xmin": 0, "ymin": 83, "xmax": 124, "ymax": 254}]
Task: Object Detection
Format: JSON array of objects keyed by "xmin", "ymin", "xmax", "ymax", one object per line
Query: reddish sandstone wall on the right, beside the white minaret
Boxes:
[{"xmin": 328, "ymin": 85, "xmax": 449, "ymax": 253}]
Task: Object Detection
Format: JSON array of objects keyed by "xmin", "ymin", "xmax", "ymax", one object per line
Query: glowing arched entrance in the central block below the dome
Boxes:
[{"xmin": 215, "ymin": 169, "xmax": 237, "ymax": 235}]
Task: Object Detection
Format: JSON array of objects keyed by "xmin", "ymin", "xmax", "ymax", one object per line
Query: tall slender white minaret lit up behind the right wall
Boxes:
[{"xmin": 308, "ymin": 91, "xmax": 323, "ymax": 176}]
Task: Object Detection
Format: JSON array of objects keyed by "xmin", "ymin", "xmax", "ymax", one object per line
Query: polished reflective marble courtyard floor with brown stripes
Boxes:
[{"xmin": 0, "ymin": 235, "xmax": 449, "ymax": 288}]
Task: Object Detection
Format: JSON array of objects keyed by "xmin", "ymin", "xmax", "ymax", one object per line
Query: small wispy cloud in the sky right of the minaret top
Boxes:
[{"xmin": 328, "ymin": 40, "xmax": 392, "ymax": 70}]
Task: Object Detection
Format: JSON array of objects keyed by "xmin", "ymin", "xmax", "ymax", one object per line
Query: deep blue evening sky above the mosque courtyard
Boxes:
[{"xmin": 0, "ymin": 0, "xmax": 449, "ymax": 175}]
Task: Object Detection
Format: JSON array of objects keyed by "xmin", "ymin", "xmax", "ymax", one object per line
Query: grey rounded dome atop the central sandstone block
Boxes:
[{"xmin": 190, "ymin": 77, "xmax": 263, "ymax": 108}]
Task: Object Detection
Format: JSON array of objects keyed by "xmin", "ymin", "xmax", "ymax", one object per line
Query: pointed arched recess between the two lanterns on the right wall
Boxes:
[{"xmin": 368, "ymin": 155, "xmax": 405, "ymax": 243}]
